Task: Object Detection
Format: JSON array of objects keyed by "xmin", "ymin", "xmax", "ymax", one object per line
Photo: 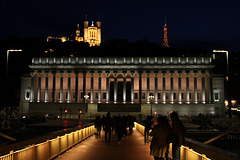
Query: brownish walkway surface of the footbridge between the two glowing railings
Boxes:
[{"xmin": 55, "ymin": 128, "xmax": 154, "ymax": 160}]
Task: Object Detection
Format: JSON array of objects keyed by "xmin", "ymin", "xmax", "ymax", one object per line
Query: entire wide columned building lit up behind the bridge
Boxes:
[{"xmin": 20, "ymin": 57, "xmax": 225, "ymax": 116}]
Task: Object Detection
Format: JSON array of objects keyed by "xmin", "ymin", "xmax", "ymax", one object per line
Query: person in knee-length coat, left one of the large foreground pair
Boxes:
[{"xmin": 150, "ymin": 116, "xmax": 171, "ymax": 160}]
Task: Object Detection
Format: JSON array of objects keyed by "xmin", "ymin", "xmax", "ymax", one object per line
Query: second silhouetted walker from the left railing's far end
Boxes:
[{"xmin": 103, "ymin": 112, "xmax": 112, "ymax": 145}]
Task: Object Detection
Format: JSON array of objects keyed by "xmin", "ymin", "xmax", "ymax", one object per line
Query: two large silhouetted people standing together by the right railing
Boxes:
[{"xmin": 146, "ymin": 112, "xmax": 186, "ymax": 160}]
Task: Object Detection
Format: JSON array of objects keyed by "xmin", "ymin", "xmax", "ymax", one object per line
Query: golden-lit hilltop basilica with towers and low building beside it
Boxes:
[{"xmin": 47, "ymin": 20, "xmax": 101, "ymax": 47}]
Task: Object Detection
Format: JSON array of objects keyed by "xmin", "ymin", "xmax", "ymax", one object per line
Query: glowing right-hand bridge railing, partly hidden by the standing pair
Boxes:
[{"xmin": 134, "ymin": 122, "xmax": 240, "ymax": 160}]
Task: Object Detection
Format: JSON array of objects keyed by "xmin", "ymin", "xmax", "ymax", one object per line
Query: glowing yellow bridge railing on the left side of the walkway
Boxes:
[{"xmin": 0, "ymin": 125, "xmax": 95, "ymax": 160}]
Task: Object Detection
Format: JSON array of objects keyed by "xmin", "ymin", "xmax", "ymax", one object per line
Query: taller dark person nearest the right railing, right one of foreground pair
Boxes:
[{"xmin": 170, "ymin": 111, "xmax": 186, "ymax": 160}]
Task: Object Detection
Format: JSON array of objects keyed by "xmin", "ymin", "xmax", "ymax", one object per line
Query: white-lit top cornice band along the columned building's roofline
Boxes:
[{"xmin": 30, "ymin": 57, "xmax": 212, "ymax": 68}]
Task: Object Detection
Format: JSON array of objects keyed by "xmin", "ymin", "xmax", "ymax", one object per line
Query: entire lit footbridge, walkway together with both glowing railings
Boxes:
[{"xmin": 0, "ymin": 123, "xmax": 240, "ymax": 160}]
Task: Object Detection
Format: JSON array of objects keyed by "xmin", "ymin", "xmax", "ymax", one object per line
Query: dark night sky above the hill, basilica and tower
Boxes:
[{"xmin": 0, "ymin": 0, "xmax": 240, "ymax": 51}]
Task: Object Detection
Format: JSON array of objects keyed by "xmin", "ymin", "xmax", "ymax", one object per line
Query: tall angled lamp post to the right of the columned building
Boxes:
[{"xmin": 213, "ymin": 50, "xmax": 232, "ymax": 118}]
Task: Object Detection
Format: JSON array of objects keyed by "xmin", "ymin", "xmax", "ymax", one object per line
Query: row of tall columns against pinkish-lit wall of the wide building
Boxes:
[{"xmin": 30, "ymin": 70, "xmax": 212, "ymax": 104}]
